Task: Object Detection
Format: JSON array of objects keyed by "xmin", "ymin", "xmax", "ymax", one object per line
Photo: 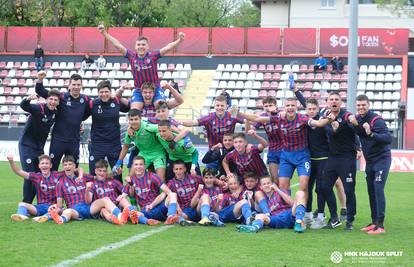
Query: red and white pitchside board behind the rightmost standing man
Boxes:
[{"xmin": 360, "ymin": 150, "xmax": 414, "ymax": 172}]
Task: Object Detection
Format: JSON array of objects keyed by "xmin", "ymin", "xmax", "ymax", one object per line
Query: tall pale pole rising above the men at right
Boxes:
[{"xmin": 346, "ymin": 0, "xmax": 358, "ymax": 114}]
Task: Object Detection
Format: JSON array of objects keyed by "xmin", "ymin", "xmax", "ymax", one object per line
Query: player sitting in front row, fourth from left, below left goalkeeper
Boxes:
[{"xmin": 124, "ymin": 156, "xmax": 179, "ymax": 224}]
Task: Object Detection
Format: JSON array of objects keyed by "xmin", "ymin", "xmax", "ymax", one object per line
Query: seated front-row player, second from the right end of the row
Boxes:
[{"xmin": 218, "ymin": 177, "xmax": 252, "ymax": 224}]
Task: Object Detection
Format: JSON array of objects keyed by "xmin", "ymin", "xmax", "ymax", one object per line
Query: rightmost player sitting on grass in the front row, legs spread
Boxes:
[{"xmin": 237, "ymin": 176, "xmax": 306, "ymax": 233}]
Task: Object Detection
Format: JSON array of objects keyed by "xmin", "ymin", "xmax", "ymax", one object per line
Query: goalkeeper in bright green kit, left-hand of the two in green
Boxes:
[{"xmin": 115, "ymin": 109, "xmax": 166, "ymax": 181}]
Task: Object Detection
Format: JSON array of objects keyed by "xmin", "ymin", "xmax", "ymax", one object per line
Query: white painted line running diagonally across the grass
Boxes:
[{"xmin": 52, "ymin": 226, "xmax": 172, "ymax": 267}]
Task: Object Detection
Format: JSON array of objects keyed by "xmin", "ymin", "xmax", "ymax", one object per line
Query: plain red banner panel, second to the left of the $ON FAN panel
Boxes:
[{"xmin": 247, "ymin": 28, "xmax": 280, "ymax": 54}]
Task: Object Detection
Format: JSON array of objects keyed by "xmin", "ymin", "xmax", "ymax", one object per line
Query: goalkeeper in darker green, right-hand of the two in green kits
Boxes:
[{"xmin": 157, "ymin": 120, "xmax": 198, "ymax": 180}]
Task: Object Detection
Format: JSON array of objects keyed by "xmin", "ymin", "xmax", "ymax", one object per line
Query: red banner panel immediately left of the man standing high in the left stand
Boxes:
[{"xmin": 7, "ymin": 27, "xmax": 37, "ymax": 52}]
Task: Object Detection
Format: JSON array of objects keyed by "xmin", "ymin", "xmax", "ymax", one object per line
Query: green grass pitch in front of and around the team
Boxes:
[{"xmin": 0, "ymin": 162, "xmax": 414, "ymax": 267}]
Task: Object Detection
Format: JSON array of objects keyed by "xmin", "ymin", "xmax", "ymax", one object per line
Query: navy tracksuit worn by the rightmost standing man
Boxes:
[{"xmin": 356, "ymin": 111, "xmax": 392, "ymax": 227}]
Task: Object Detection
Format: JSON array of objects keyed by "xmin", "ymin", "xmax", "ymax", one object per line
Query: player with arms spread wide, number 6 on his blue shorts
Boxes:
[{"xmin": 241, "ymin": 98, "xmax": 332, "ymax": 192}]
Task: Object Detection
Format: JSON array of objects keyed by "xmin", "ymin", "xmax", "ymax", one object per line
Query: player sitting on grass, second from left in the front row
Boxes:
[{"xmin": 49, "ymin": 155, "xmax": 128, "ymax": 224}]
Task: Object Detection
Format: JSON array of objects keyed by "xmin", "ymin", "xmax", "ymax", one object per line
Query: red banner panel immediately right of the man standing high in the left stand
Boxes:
[{"xmin": 40, "ymin": 27, "xmax": 72, "ymax": 52}]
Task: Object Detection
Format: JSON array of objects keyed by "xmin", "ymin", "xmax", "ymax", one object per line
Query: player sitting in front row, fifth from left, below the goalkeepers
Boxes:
[{"xmin": 168, "ymin": 160, "xmax": 203, "ymax": 226}]
